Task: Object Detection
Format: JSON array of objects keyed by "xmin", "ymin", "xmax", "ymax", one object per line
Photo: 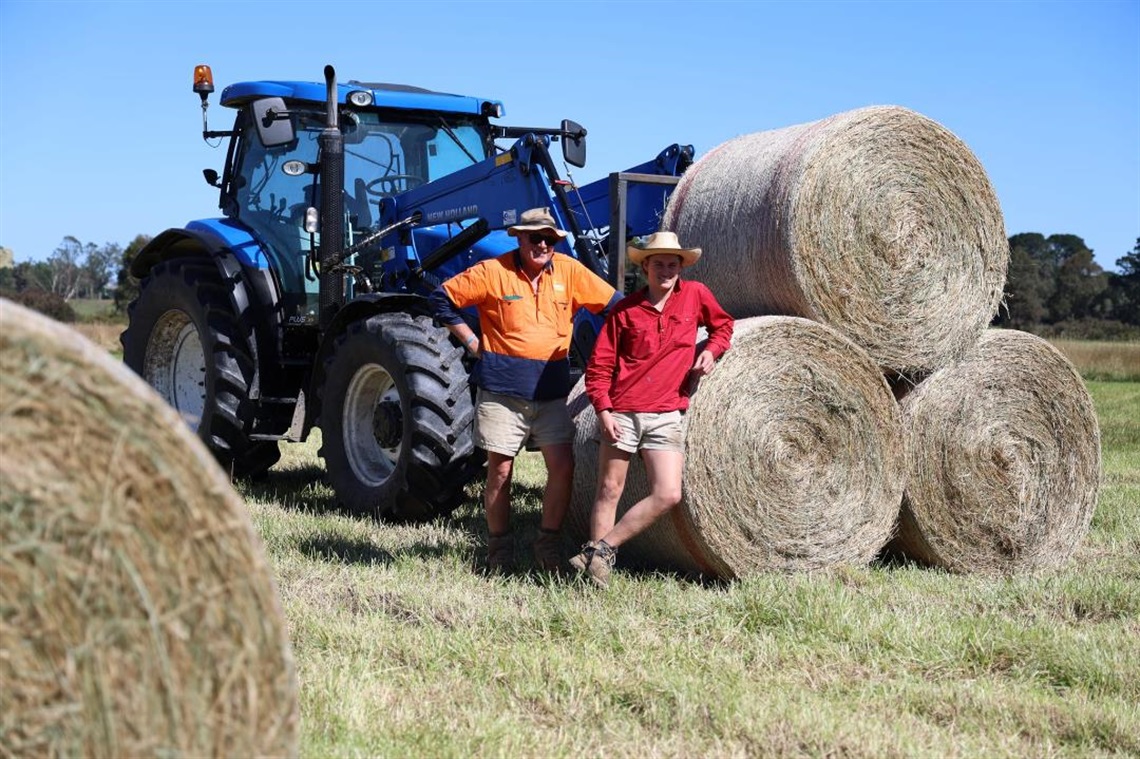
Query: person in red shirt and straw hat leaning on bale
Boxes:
[{"xmin": 570, "ymin": 232, "xmax": 733, "ymax": 587}]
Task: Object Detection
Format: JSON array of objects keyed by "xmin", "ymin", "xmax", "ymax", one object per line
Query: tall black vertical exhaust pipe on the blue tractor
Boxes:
[{"xmin": 317, "ymin": 66, "xmax": 344, "ymax": 333}]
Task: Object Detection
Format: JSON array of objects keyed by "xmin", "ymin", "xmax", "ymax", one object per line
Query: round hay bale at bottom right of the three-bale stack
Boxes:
[{"xmin": 890, "ymin": 329, "xmax": 1100, "ymax": 573}]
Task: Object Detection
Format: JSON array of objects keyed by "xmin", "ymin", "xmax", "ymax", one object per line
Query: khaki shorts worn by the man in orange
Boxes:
[{"xmin": 475, "ymin": 387, "xmax": 575, "ymax": 456}]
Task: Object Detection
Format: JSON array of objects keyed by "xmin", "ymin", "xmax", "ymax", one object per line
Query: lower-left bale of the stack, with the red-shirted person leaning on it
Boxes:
[{"xmin": 568, "ymin": 317, "xmax": 905, "ymax": 579}]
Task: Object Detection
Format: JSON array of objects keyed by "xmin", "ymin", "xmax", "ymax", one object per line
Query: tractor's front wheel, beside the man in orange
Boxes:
[{"xmin": 320, "ymin": 312, "xmax": 485, "ymax": 522}]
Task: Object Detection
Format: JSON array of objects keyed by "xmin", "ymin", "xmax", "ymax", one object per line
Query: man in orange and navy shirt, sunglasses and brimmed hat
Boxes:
[{"xmin": 431, "ymin": 203, "xmax": 619, "ymax": 572}]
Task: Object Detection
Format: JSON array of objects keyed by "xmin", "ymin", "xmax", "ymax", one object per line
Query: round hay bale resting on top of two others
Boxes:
[{"xmin": 662, "ymin": 106, "xmax": 1009, "ymax": 375}]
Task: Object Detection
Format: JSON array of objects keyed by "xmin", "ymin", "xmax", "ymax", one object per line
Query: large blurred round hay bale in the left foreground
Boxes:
[{"xmin": 0, "ymin": 300, "xmax": 298, "ymax": 757}]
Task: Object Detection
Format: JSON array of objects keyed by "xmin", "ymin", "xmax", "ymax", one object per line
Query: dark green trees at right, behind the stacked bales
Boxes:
[{"xmin": 994, "ymin": 232, "xmax": 1140, "ymax": 340}]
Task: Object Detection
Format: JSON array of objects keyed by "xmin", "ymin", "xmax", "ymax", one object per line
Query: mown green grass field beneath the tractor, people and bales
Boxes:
[{"xmin": 233, "ymin": 382, "xmax": 1140, "ymax": 757}]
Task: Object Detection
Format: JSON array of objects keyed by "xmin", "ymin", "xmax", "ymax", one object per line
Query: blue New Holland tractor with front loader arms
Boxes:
[{"xmin": 121, "ymin": 66, "xmax": 693, "ymax": 521}]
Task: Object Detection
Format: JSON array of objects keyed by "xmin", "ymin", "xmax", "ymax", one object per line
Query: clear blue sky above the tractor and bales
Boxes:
[{"xmin": 0, "ymin": 0, "xmax": 1140, "ymax": 269}]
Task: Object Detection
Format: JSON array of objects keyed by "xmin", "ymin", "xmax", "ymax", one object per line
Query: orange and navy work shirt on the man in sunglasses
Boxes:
[{"xmin": 431, "ymin": 251, "xmax": 620, "ymax": 400}]
